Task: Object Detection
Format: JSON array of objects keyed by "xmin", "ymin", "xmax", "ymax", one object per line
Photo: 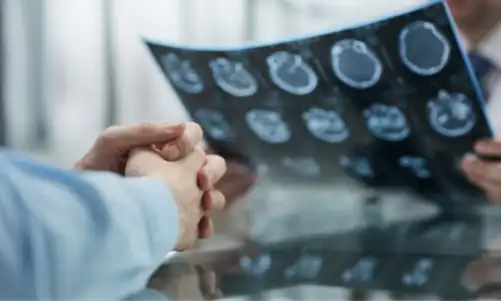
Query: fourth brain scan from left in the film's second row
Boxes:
[{"xmin": 364, "ymin": 104, "xmax": 410, "ymax": 141}]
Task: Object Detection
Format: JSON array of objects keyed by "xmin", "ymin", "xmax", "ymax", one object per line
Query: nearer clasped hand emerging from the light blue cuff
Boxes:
[{"xmin": 125, "ymin": 147, "xmax": 226, "ymax": 251}]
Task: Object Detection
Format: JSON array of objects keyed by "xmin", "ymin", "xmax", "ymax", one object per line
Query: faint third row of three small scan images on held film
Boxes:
[{"xmin": 279, "ymin": 155, "xmax": 431, "ymax": 179}]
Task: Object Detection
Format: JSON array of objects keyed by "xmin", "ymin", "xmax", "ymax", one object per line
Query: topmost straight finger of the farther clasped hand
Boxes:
[{"xmin": 96, "ymin": 123, "xmax": 186, "ymax": 151}]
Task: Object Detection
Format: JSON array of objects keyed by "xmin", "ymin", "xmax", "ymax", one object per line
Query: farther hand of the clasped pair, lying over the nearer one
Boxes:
[{"xmin": 75, "ymin": 122, "xmax": 203, "ymax": 175}]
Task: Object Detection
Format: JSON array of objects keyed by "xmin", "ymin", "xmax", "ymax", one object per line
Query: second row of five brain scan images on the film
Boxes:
[{"xmin": 194, "ymin": 90, "xmax": 477, "ymax": 144}]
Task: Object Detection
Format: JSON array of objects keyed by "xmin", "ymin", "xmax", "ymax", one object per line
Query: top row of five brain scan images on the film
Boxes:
[{"xmin": 161, "ymin": 21, "xmax": 451, "ymax": 97}]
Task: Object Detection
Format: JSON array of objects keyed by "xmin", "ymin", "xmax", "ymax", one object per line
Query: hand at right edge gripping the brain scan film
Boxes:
[{"xmin": 461, "ymin": 140, "xmax": 501, "ymax": 205}]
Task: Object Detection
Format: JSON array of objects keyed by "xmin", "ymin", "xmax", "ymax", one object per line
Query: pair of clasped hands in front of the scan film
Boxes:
[{"xmin": 75, "ymin": 122, "xmax": 226, "ymax": 251}]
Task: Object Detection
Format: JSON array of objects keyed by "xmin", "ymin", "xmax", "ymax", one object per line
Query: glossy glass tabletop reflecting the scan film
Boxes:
[{"xmin": 141, "ymin": 179, "xmax": 501, "ymax": 300}]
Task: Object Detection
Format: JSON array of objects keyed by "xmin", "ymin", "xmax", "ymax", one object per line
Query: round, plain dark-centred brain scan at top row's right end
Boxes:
[{"xmin": 399, "ymin": 21, "xmax": 451, "ymax": 76}]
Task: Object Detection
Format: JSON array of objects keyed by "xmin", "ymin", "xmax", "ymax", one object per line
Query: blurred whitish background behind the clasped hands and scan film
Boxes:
[{"xmin": 0, "ymin": 0, "xmax": 425, "ymax": 166}]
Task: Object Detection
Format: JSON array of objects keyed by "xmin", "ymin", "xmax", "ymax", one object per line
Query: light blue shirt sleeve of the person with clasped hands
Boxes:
[{"xmin": 0, "ymin": 152, "xmax": 179, "ymax": 300}]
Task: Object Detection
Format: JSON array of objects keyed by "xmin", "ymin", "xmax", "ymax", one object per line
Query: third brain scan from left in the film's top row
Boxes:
[{"xmin": 266, "ymin": 51, "xmax": 318, "ymax": 95}]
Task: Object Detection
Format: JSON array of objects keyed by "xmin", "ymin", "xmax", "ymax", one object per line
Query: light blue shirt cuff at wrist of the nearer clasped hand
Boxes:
[{"xmin": 127, "ymin": 178, "xmax": 180, "ymax": 263}]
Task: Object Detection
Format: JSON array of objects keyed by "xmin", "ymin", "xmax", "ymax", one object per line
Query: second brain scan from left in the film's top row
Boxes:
[{"xmin": 209, "ymin": 58, "xmax": 258, "ymax": 97}]
